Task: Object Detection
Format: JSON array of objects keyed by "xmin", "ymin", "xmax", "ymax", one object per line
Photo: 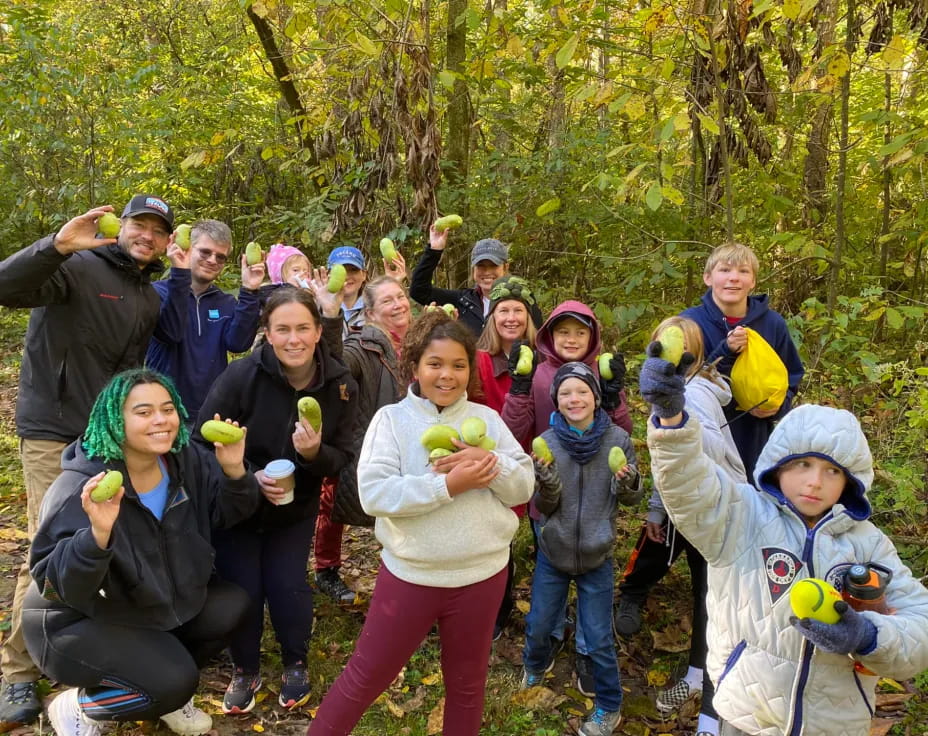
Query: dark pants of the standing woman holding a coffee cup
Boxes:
[{"xmin": 213, "ymin": 517, "xmax": 316, "ymax": 672}]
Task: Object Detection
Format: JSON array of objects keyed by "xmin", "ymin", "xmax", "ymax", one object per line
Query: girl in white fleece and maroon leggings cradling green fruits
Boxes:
[{"xmin": 309, "ymin": 311, "xmax": 535, "ymax": 736}]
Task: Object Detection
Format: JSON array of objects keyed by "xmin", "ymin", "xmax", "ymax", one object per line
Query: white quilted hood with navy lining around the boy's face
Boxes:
[{"xmin": 754, "ymin": 404, "xmax": 873, "ymax": 521}]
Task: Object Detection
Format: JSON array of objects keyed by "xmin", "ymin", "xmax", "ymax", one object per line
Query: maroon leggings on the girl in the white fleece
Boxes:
[{"xmin": 308, "ymin": 564, "xmax": 506, "ymax": 736}]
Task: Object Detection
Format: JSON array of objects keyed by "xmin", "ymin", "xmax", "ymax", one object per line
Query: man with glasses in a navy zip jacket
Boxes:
[{"xmin": 146, "ymin": 220, "xmax": 264, "ymax": 422}]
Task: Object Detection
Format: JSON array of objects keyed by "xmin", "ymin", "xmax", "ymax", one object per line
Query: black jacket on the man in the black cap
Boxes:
[{"xmin": 0, "ymin": 235, "xmax": 163, "ymax": 442}]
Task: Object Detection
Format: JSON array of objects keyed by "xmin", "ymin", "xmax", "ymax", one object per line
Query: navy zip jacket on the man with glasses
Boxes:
[{"xmin": 145, "ymin": 268, "xmax": 261, "ymax": 422}]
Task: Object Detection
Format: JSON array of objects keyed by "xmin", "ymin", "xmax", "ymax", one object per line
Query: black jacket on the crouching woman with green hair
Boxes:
[{"xmin": 29, "ymin": 440, "xmax": 261, "ymax": 631}]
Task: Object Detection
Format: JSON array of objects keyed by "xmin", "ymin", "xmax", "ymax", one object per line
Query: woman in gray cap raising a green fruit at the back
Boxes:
[{"xmin": 409, "ymin": 225, "xmax": 544, "ymax": 336}]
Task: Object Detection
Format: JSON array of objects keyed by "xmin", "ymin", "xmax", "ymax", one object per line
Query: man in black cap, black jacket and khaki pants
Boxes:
[{"xmin": 0, "ymin": 194, "xmax": 188, "ymax": 730}]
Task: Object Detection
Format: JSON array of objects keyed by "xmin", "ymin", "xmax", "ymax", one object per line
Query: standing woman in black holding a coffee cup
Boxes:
[{"xmin": 198, "ymin": 288, "xmax": 357, "ymax": 713}]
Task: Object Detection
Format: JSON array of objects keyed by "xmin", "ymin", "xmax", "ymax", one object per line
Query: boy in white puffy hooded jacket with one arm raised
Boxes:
[{"xmin": 640, "ymin": 343, "xmax": 928, "ymax": 736}]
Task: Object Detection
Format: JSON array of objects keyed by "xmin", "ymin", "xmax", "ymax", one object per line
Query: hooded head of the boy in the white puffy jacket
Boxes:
[{"xmin": 754, "ymin": 404, "xmax": 873, "ymax": 523}]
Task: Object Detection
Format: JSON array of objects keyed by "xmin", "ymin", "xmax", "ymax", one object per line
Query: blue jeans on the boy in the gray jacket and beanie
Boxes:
[{"xmin": 522, "ymin": 549, "xmax": 622, "ymax": 712}]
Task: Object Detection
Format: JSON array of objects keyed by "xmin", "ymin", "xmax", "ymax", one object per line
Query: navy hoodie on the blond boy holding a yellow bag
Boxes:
[{"xmin": 681, "ymin": 289, "xmax": 805, "ymax": 478}]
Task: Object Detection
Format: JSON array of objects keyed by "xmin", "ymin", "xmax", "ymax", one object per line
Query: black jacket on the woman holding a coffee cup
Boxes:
[{"xmin": 195, "ymin": 340, "xmax": 358, "ymax": 530}]
